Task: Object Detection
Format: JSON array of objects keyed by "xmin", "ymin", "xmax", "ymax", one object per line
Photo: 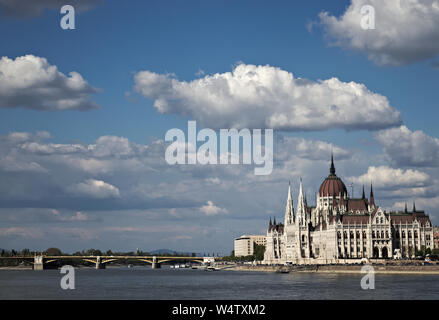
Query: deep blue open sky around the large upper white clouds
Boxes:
[{"xmin": 0, "ymin": 1, "xmax": 439, "ymax": 142}]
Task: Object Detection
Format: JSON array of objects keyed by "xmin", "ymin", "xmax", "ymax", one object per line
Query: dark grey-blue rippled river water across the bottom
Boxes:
[{"xmin": 0, "ymin": 267, "xmax": 439, "ymax": 300}]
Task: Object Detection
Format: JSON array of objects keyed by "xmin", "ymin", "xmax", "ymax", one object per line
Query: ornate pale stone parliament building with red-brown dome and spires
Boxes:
[{"xmin": 264, "ymin": 156, "xmax": 434, "ymax": 264}]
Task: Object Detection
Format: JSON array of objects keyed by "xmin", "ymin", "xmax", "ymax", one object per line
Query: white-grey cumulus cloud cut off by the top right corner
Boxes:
[{"xmin": 319, "ymin": 0, "xmax": 439, "ymax": 65}]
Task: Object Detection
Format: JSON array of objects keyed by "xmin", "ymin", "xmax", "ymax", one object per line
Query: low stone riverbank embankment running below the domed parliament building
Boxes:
[{"xmin": 226, "ymin": 265, "xmax": 439, "ymax": 275}]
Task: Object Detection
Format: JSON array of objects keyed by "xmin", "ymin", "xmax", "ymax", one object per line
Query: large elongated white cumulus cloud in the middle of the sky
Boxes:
[{"xmin": 134, "ymin": 64, "xmax": 401, "ymax": 131}]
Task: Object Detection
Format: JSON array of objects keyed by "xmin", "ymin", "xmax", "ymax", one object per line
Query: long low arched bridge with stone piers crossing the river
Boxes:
[{"xmin": 0, "ymin": 255, "xmax": 215, "ymax": 270}]
